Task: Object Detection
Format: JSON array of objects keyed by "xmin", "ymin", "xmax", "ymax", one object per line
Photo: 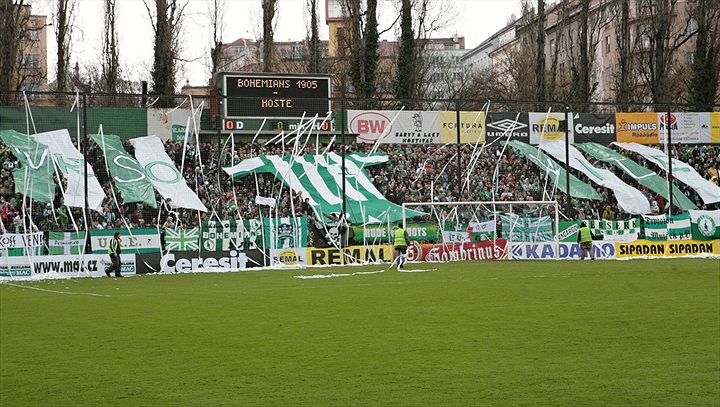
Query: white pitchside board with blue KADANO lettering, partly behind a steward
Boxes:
[{"xmin": 510, "ymin": 242, "xmax": 615, "ymax": 260}]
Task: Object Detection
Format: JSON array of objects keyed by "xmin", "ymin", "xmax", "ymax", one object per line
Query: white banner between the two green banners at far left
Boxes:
[{"xmin": 36, "ymin": 129, "xmax": 105, "ymax": 212}]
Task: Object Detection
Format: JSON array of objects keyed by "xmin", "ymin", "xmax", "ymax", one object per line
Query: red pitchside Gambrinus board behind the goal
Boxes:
[{"xmin": 407, "ymin": 239, "xmax": 508, "ymax": 262}]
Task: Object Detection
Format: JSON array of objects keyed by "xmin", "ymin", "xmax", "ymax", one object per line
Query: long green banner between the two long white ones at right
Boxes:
[{"xmin": 575, "ymin": 143, "xmax": 697, "ymax": 210}]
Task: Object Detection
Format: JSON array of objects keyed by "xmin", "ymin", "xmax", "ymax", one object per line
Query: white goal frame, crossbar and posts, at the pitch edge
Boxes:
[{"xmin": 402, "ymin": 201, "xmax": 560, "ymax": 259}]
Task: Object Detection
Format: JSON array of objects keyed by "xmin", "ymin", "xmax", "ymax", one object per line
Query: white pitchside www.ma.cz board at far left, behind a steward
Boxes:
[{"xmin": 0, "ymin": 254, "xmax": 136, "ymax": 277}]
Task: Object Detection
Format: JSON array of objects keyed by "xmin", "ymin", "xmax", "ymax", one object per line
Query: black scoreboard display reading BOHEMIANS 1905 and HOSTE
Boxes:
[{"xmin": 221, "ymin": 73, "xmax": 332, "ymax": 120}]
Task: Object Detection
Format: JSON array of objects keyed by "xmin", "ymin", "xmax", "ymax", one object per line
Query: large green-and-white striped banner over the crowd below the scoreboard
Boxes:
[{"xmin": 224, "ymin": 153, "xmax": 423, "ymax": 225}]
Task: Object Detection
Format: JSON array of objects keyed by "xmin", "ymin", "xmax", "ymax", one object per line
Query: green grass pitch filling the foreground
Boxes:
[{"xmin": 0, "ymin": 259, "xmax": 720, "ymax": 406}]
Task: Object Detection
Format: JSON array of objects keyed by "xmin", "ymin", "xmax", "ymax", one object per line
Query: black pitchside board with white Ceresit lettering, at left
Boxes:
[{"xmin": 137, "ymin": 250, "xmax": 268, "ymax": 274}]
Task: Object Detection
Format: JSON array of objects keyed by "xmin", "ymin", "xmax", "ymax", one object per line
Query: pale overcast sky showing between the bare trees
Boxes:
[{"xmin": 33, "ymin": 0, "xmax": 520, "ymax": 86}]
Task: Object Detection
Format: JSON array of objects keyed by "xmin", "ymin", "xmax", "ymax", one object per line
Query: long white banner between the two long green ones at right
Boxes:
[{"xmin": 539, "ymin": 141, "xmax": 650, "ymax": 215}]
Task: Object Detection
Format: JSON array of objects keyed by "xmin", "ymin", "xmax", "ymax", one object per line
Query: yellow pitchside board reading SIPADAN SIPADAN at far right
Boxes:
[{"xmin": 615, "ymin": 239, "xmax": 720, "ymax": 259}]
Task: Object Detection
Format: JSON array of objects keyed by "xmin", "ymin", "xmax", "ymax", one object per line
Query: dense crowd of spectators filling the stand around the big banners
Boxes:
[{"xmin": 0, "ymin": 135, "xmax": 720, "ymax": 232}]
